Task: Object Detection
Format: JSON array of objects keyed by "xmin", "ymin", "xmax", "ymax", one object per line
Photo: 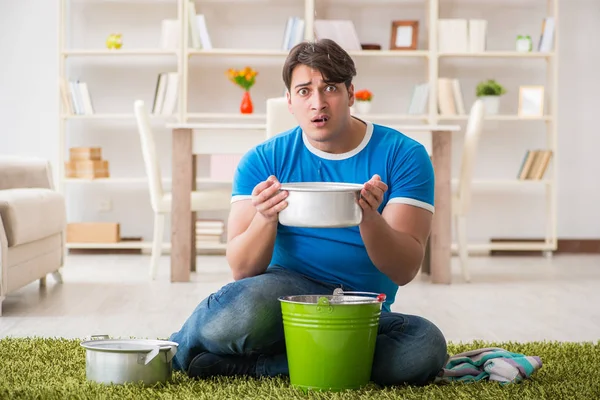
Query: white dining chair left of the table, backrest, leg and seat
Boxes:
[{"xmin": 134, "ymin": 100, "xmax": 231, "ymax": 279}]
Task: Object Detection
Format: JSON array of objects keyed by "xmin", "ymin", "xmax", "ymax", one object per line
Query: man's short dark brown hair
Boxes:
[{"xmin": 283, "ymin": 39, "xmax": 356, "ymax": 91}]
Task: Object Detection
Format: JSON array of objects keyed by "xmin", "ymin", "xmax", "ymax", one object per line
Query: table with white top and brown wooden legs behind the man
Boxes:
[{"xmin": 167, "ymin": 123, "xmax": 460, "ymax": 284}]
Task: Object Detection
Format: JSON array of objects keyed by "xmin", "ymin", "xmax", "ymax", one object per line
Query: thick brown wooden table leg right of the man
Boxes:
[{"xmin": 430, "ymin": 132, "xmax": 452, "ymax": 284}]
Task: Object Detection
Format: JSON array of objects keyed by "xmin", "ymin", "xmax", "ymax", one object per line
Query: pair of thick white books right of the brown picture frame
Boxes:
[{"xmin": 438, "ymin": 18, "xmax": 487, "ymax": 53}]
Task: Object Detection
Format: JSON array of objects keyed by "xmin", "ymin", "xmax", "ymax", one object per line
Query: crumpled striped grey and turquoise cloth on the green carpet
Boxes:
[{"xmin": 436, "ymin": 347, "xmax": 542, "ymax": 384}]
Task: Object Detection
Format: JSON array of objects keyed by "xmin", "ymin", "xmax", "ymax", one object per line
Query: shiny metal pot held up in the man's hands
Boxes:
[{"xmin": 279, "ymin": 182, "xmax": 363, "ymax": 228}]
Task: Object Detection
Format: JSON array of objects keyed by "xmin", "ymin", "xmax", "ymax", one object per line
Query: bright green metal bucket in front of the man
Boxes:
[{"xmin": 279, "ymin": 289, "xmax": 385, "ymax": 392}]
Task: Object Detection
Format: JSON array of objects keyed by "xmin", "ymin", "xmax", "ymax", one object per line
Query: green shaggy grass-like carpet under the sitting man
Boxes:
[{"xmin": 0, "ymin": 338, "xmax": 600, "ymax": 400}]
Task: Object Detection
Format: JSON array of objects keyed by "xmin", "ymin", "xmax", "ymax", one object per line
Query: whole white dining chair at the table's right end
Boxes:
[{"xmin": 452, "ymin": 100, "xmax": 485, "ymax": 282}]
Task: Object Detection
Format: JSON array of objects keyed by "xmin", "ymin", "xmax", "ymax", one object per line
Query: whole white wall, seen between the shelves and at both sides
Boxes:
[{"xmin": 0, "ymin": 0, "xmax": 600, "ymax": 242}]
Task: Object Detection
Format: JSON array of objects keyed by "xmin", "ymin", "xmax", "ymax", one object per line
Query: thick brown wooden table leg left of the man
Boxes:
[{"xmin": 171, "ymin": 129, "xmax": 194, "ymax": 282}]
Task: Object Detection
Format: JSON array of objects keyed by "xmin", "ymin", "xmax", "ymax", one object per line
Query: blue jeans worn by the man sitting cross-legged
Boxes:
[{"xmin": 170, "ymin": 266, "xmax": 447, "ymax": 386}]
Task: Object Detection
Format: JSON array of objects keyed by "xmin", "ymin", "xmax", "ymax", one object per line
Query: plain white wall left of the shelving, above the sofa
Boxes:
[{"xmin": 0, "ymin": 0, "xmax": 58, "ymax": 172}]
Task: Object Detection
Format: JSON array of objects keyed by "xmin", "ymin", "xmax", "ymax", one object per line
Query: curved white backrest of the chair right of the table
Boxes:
[{"xmin": 457, "ymin": 100, "xmax": 485, "ymax": 214}]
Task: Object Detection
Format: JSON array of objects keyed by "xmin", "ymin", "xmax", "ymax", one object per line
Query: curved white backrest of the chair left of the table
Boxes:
[{"xmin": 133, "ymin": 100, "xmax": 164, "ymax": 211}]
